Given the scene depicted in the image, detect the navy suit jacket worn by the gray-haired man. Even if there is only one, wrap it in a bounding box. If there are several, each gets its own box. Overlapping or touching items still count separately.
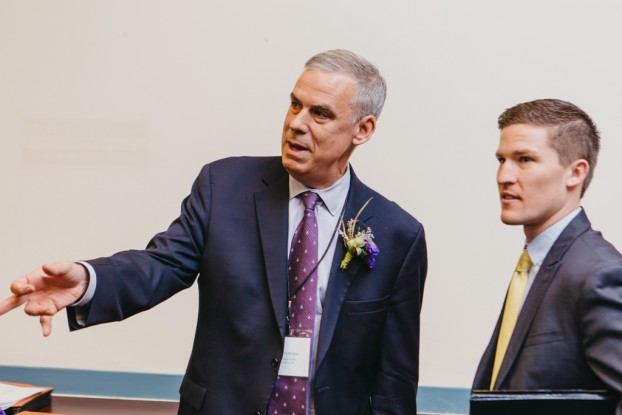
[69,157,427,415]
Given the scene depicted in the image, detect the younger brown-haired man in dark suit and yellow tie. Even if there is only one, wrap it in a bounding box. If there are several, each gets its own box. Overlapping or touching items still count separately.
[473,99,622,413]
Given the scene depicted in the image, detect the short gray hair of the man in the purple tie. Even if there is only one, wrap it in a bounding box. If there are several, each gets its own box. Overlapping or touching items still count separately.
[305,49,387,122]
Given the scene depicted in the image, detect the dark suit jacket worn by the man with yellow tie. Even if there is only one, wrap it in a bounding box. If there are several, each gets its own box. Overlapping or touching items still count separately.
[473,211,622,413]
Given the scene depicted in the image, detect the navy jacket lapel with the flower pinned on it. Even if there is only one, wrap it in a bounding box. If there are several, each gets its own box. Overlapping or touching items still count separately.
[315,170,374,368]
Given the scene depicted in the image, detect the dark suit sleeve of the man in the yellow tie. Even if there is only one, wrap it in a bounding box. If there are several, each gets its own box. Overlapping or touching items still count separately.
[579,264,622,415]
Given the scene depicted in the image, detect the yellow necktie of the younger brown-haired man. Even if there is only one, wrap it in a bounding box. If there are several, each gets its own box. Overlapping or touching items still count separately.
[490,248,532,390]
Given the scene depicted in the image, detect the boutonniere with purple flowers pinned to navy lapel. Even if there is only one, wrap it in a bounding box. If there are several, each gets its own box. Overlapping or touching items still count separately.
[339,197,380,269]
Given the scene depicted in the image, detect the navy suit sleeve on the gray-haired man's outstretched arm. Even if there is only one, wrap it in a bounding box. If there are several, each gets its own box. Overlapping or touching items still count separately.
[68,165,211,329]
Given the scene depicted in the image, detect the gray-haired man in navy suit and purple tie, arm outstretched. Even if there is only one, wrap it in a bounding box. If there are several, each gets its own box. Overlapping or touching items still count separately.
[0,50,427,415]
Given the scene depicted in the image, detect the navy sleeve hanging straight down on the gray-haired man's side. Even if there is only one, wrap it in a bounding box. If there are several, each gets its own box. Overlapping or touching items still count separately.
[371,225,427,415]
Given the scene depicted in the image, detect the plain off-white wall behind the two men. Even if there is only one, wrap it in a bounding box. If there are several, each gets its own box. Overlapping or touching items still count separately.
[0,0,622,387]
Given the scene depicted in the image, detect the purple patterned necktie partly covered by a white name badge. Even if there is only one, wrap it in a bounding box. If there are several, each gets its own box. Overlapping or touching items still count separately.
[267,192,320,415]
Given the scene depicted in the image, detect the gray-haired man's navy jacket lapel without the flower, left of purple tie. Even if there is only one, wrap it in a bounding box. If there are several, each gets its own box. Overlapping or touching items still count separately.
[255,159,289,337]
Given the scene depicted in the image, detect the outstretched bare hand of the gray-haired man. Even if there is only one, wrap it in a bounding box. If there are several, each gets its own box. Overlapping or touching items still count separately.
[0,261,89,336]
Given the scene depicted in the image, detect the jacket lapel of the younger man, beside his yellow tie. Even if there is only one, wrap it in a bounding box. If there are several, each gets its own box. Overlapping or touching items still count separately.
[492,211,590,387]
